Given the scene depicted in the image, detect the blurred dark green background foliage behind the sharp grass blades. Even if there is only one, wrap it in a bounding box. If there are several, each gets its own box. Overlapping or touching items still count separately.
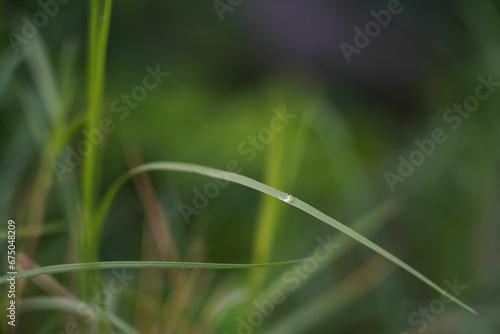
[0,0,500,334]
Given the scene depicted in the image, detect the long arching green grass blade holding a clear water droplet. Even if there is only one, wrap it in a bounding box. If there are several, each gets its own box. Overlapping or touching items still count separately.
[96,162,478,315]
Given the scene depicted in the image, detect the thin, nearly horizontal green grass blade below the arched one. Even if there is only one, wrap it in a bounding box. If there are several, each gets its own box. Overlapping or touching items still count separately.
[0,258,307,285]
